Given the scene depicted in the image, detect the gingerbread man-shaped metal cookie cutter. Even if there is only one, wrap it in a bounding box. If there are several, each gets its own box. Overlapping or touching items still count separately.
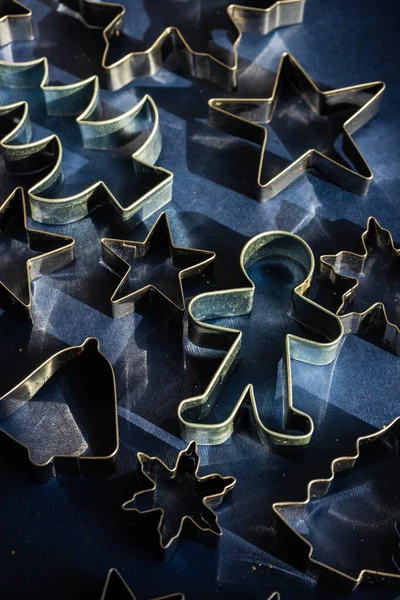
[178,231,343,452]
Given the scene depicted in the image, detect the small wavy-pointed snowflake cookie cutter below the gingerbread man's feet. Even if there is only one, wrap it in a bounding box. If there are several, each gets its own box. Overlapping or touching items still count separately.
[122,442,236,551]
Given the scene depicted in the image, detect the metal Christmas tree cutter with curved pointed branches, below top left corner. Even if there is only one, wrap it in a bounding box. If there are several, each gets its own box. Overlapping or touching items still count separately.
[0,58,173,227]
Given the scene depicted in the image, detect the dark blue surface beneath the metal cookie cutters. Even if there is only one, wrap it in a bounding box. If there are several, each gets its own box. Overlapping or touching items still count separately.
[0,0,400,600]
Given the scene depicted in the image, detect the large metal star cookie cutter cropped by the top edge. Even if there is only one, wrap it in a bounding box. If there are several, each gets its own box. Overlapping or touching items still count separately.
[57,0,306,90]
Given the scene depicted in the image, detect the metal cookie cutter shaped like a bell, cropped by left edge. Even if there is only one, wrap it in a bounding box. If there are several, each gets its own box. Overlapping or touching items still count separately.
[0,338,119,481]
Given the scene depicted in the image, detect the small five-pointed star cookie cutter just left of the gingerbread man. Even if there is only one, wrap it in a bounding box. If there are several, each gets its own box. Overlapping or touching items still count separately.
[101,212,216,318]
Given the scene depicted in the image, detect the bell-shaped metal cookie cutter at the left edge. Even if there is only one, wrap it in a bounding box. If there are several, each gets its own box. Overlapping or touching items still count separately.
[0,338,119,481]
